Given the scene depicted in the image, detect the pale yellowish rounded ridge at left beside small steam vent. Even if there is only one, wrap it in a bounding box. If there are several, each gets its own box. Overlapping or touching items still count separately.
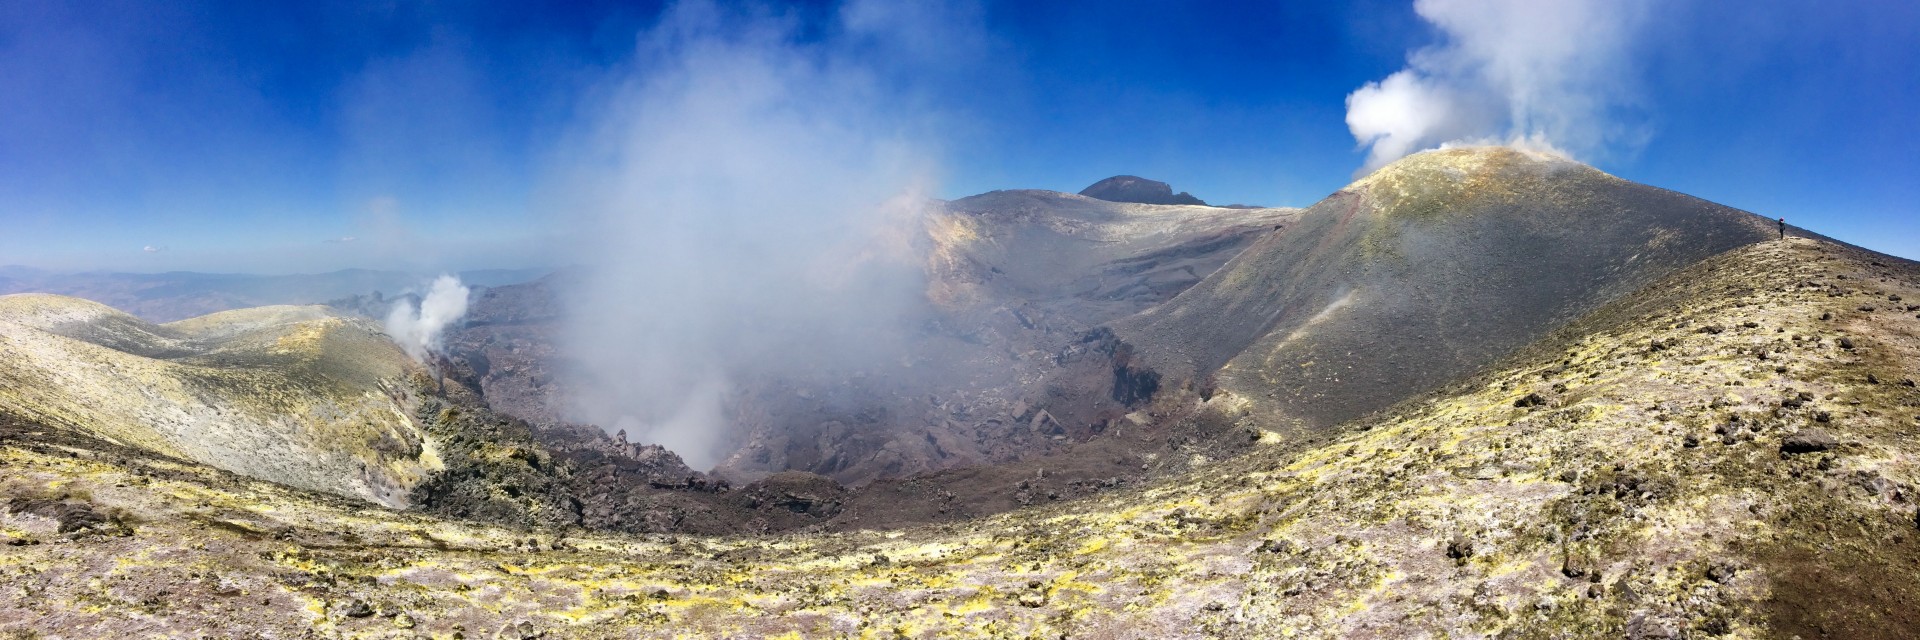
[0,294,444,507]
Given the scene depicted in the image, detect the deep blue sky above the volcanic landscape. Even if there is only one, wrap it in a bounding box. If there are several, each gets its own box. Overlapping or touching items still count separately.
[0,0,1920,273]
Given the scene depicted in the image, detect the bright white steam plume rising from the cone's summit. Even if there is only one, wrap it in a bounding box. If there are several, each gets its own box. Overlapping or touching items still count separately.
[1346,0,1649,173]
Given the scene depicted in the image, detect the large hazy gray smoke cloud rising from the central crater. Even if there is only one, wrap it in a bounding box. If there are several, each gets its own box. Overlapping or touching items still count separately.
[553,4,941,469]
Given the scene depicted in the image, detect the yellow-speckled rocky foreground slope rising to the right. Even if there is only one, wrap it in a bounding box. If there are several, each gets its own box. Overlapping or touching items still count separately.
[0,238,1920,638]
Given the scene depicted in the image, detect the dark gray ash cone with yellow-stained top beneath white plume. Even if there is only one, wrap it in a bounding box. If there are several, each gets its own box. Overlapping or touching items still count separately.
[1112,148,1812,432]
